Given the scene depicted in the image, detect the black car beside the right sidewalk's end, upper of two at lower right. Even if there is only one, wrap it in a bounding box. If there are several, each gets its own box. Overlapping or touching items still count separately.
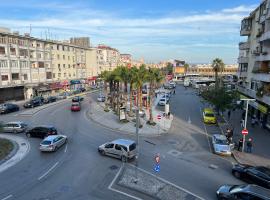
[232,165,270,188]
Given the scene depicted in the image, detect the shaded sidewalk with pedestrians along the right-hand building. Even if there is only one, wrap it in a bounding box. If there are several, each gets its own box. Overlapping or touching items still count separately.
[219,110,270,165]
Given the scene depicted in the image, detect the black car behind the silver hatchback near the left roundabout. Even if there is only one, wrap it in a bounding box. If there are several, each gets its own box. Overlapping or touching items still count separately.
[26,126,57,138]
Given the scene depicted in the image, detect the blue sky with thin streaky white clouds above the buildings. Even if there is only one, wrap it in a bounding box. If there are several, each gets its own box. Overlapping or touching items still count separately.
[0,0,261,64]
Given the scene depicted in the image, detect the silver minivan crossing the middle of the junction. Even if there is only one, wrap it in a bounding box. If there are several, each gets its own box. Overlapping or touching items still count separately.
[98,139,136,162]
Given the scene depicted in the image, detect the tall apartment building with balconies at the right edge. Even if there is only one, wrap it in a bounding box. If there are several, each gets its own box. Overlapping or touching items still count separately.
[238,0,270,128]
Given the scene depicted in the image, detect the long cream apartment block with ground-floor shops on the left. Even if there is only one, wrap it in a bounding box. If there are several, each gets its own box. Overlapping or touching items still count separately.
[0,28,97,102]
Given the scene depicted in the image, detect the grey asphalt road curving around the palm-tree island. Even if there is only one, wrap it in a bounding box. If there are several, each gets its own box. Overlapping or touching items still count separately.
[0,86,241,200]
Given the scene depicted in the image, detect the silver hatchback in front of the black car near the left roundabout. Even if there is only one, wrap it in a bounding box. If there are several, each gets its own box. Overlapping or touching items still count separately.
[39,135,67,151]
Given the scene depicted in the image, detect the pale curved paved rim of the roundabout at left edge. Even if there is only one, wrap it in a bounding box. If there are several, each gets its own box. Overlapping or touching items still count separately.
[0,134,30,173]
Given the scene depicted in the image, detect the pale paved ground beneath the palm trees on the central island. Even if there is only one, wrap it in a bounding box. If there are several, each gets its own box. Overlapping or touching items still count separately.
[87,95,173,136]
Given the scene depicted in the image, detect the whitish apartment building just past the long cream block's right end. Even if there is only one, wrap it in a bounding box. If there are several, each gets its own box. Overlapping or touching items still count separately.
[97,44,120,73]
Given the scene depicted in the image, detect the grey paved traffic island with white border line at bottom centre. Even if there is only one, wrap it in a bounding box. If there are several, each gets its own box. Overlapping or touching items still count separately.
[111,165,201,200]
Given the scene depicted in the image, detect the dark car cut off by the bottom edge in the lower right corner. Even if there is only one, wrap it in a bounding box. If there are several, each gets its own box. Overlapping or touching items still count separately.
[216,185,270,200]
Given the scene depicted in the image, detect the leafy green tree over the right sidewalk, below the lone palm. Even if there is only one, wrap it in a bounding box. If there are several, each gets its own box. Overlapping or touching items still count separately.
[201,87,238,113]
